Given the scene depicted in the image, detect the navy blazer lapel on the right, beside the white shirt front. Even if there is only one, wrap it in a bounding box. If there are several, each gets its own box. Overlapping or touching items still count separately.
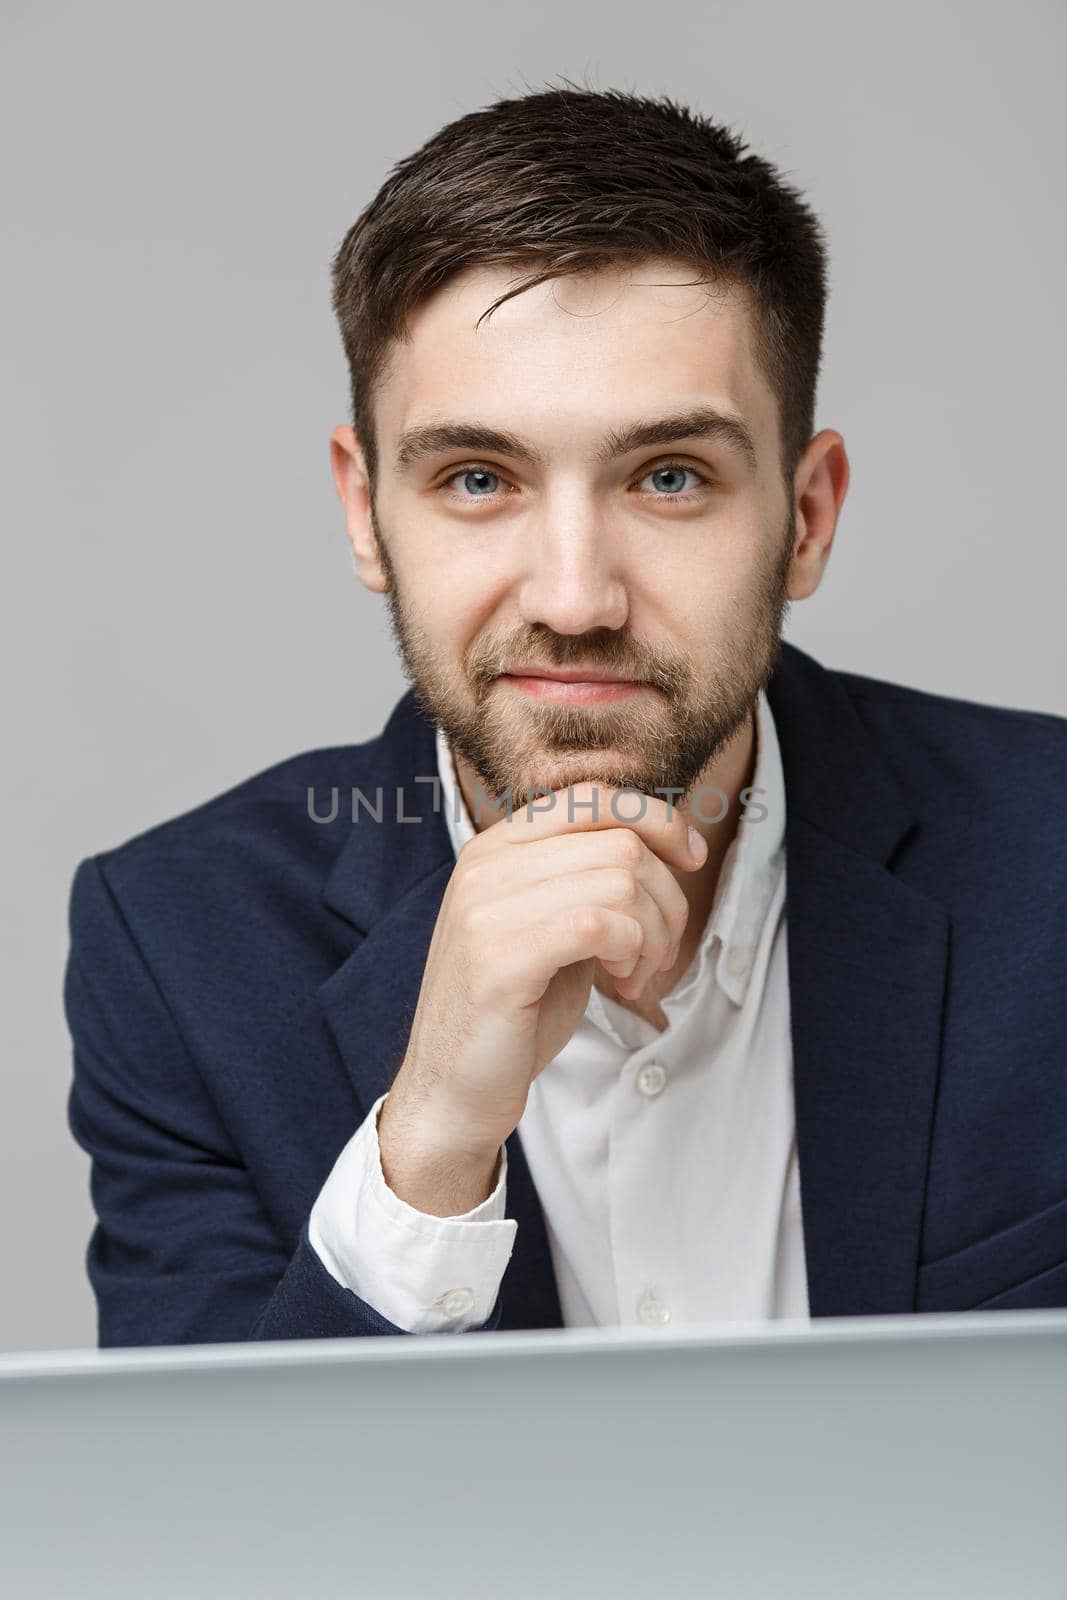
[768,645,950,1317]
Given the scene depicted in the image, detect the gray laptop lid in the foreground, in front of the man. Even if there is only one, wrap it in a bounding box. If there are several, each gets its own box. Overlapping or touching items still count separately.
[0,1312,1067,1600]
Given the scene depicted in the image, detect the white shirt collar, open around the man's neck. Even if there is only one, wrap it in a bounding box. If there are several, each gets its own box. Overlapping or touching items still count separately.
[437,690,785,1005]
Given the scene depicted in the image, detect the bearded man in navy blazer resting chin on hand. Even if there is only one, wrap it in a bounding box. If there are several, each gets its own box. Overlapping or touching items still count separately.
[66,90,1067,1346]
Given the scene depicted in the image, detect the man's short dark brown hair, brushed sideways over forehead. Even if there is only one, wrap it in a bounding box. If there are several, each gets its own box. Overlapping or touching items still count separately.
[333,80,827,491]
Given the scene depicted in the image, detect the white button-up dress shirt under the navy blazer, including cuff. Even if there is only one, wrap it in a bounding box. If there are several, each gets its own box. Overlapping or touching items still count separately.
[309,693,808,1333]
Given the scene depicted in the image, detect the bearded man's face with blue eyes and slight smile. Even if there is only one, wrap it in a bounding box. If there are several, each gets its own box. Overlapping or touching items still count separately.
[358,262,793,805]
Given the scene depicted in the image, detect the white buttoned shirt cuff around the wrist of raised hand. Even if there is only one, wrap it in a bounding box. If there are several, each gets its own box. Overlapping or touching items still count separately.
[307,1094,518,1333]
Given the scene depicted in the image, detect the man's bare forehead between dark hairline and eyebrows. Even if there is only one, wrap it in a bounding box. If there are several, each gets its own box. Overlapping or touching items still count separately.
[376,259,777,451]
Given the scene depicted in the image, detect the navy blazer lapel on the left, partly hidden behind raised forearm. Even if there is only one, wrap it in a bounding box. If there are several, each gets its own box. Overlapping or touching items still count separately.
[318,690,563,1328]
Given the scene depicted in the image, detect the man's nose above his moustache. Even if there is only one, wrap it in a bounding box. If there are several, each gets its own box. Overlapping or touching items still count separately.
[518,514,629,634]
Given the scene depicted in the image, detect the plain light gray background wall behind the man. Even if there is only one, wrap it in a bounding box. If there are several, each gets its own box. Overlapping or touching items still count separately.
[0,0,1067,1350]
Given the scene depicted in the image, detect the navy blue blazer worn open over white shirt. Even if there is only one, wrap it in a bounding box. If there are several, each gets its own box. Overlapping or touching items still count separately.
[64,645,1067,1346]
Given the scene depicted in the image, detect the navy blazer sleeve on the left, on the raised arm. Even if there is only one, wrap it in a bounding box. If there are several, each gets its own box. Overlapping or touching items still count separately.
[64,856,501,1347]
